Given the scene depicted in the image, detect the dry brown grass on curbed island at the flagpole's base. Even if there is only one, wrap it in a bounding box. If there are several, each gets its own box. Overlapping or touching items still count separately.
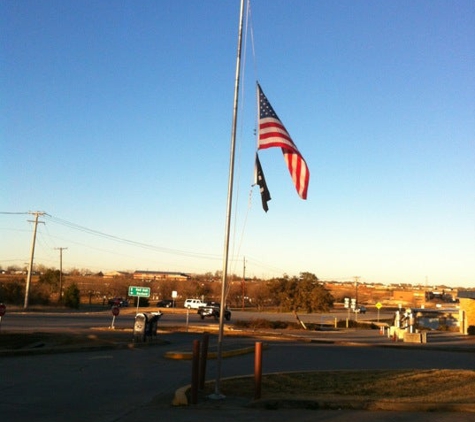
[206,369,475,403]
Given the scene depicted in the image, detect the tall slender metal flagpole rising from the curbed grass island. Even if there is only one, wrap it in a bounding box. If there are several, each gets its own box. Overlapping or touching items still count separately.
[214,0,244,399]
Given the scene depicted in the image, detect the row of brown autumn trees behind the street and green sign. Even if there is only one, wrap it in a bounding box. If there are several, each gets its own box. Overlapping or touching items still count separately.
[0,268,335,313]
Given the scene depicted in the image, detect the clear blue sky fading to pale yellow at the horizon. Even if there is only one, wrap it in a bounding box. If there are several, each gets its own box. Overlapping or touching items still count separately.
[0,0,475,287]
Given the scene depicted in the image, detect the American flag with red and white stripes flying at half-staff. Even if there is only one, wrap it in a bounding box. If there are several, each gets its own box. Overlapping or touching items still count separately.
[257,84,310,199]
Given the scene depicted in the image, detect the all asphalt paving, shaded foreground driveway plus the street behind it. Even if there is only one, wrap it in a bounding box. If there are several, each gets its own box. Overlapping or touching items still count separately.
[0,309,475,422]
